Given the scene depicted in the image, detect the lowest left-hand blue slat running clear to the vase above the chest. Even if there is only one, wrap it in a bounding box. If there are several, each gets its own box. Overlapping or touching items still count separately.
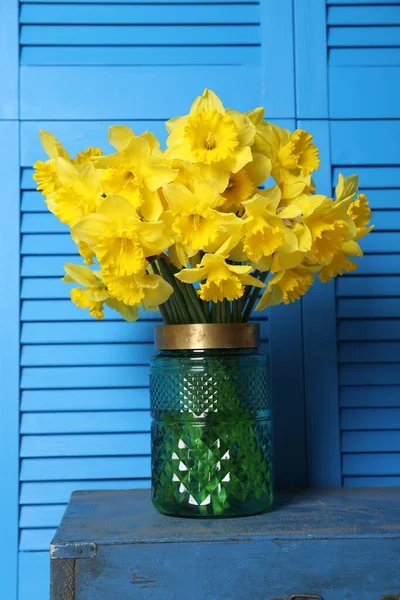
[20,456,150,481]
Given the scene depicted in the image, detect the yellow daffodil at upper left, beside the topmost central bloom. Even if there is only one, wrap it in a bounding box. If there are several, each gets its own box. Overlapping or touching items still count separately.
[94,136,176,221]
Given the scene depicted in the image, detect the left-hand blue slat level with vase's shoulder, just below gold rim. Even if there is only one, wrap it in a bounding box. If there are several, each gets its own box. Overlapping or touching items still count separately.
[21,343,155,367]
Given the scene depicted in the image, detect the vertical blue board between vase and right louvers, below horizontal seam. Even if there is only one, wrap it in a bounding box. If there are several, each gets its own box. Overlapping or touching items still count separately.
[299,120,342,486]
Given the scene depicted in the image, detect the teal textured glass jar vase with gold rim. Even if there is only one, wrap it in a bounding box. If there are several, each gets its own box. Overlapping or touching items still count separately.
[150,324,273,517]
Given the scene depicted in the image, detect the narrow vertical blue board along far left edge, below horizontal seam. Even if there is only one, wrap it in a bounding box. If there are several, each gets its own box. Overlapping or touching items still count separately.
[0,120,20,600]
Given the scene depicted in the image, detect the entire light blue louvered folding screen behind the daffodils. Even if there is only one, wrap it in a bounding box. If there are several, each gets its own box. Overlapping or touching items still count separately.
[0,0,400,600]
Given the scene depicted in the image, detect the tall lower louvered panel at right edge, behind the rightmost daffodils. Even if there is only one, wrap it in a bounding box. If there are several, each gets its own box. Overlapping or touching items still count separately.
[330,116,400,486]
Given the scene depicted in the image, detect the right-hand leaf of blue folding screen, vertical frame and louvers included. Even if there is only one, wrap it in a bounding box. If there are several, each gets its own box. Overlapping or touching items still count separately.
[294,0,400,486]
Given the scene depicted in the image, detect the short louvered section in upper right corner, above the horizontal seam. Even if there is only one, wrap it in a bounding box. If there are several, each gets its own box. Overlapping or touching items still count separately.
[327,2,400,117]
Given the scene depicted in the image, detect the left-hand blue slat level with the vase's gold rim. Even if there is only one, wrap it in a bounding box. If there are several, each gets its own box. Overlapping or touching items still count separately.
[21,321,153,344]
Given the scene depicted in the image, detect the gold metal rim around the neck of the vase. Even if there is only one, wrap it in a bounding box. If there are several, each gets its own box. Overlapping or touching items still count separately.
[154,323,260,350]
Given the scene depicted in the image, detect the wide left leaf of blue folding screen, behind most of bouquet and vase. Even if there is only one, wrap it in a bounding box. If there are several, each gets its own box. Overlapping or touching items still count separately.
[0,0,306,600]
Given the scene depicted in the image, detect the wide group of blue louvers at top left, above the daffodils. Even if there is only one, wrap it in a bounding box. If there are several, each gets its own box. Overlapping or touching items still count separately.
[20,1,261,66]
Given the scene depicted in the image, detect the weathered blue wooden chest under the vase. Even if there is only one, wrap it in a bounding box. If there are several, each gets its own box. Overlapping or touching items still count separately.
[50,488,400,600]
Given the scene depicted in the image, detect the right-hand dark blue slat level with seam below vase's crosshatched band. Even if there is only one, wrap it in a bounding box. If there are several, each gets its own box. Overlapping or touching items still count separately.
[340,408,400,432]
